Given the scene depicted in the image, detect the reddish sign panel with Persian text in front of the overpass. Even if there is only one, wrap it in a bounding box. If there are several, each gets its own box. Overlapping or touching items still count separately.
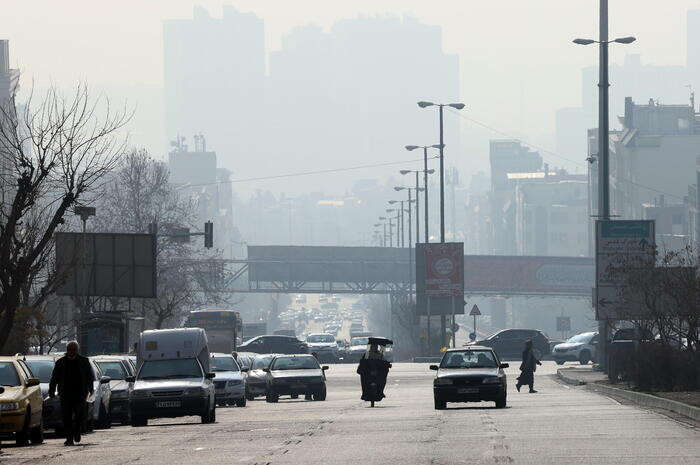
[424,242,464,297]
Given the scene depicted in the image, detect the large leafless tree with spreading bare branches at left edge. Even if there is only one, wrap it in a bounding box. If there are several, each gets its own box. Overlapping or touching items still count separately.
[0,85,131,347]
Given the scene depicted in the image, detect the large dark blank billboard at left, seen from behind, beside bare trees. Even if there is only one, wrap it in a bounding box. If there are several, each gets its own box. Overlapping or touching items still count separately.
[55,233,157,298]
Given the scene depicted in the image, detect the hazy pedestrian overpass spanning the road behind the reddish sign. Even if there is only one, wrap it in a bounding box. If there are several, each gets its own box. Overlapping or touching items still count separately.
[211,246,595,298]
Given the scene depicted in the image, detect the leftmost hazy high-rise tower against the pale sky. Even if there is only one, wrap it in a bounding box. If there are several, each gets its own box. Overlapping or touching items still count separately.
[163,6,265,167]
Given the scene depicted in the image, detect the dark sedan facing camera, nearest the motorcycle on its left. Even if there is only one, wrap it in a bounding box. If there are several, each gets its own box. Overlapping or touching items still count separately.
[263,354,328,402]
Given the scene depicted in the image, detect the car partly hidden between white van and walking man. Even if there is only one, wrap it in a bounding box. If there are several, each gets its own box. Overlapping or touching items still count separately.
[92,355,136,425]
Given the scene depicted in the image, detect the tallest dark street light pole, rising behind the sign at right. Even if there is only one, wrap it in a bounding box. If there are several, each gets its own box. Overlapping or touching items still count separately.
[574,0,637,372]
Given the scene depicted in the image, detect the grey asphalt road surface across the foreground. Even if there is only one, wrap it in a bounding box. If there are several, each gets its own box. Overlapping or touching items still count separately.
[0,362,700,465]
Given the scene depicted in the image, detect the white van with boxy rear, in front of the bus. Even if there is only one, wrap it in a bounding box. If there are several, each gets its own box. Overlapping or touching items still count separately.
[127,328,216,426]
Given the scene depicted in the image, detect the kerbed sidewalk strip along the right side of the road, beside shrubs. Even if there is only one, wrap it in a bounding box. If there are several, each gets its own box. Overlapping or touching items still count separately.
[557,366,700,421]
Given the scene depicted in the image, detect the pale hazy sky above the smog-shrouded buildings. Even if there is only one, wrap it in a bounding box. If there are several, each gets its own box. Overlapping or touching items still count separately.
[0,0,700,191]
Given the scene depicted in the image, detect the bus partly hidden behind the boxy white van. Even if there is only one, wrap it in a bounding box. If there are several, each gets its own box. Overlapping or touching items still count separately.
[185,308,242,354]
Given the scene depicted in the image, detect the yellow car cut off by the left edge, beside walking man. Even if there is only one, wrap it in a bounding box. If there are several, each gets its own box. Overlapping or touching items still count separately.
[0,357,44,446]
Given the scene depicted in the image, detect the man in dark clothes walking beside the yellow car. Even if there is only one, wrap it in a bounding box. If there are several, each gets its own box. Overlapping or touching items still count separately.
[49,341,95,446]
